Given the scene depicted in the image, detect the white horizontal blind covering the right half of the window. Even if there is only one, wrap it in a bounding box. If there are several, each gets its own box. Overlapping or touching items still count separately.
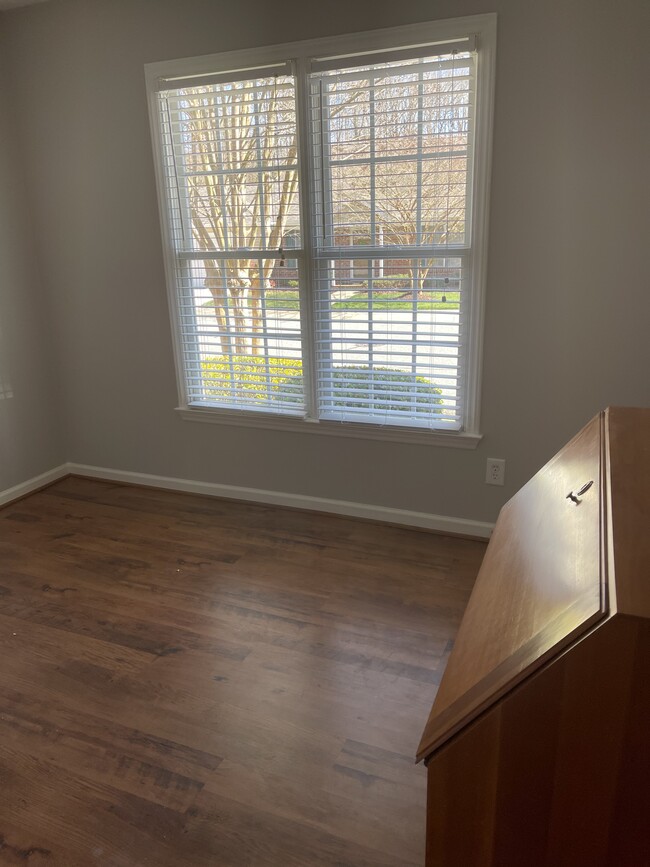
[310,51,475,430]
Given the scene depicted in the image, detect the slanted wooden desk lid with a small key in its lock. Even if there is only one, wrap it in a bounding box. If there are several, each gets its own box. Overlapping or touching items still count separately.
[418,416,606,758]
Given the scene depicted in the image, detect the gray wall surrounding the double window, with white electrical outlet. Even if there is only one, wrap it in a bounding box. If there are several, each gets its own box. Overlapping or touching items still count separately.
[0,0,650,520]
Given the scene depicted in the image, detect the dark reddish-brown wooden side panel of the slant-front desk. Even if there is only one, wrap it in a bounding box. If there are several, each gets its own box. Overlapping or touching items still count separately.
[426,615,650,867]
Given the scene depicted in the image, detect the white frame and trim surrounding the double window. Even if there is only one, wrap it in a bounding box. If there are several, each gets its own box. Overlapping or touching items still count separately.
[145,13,496,449]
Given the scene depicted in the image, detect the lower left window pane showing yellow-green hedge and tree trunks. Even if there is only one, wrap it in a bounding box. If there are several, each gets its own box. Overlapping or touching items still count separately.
[178,258,304,415]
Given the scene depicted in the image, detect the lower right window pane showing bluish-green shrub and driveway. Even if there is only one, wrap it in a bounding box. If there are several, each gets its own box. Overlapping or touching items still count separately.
[316,258,463,428]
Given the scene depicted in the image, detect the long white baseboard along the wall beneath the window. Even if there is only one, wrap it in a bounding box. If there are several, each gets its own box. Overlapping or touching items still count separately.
[67,463,494,539]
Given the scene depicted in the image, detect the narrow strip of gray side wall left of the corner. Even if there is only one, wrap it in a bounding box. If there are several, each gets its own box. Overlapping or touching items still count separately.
[0,64,65,491]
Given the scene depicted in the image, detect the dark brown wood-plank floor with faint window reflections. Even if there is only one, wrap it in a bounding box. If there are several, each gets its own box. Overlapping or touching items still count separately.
[0,478,485,867]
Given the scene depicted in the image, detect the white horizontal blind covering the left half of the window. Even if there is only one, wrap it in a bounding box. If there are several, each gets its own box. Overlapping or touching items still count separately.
[158,68,304,415]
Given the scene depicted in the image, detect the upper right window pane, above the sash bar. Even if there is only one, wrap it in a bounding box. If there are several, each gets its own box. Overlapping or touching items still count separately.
[312,55,473,246]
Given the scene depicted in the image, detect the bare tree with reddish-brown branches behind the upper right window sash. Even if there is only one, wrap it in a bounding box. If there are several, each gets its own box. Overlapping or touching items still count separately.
[331,73,468,292]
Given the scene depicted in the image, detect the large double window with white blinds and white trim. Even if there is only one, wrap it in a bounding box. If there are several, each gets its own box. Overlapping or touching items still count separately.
[147,16,494,439]
